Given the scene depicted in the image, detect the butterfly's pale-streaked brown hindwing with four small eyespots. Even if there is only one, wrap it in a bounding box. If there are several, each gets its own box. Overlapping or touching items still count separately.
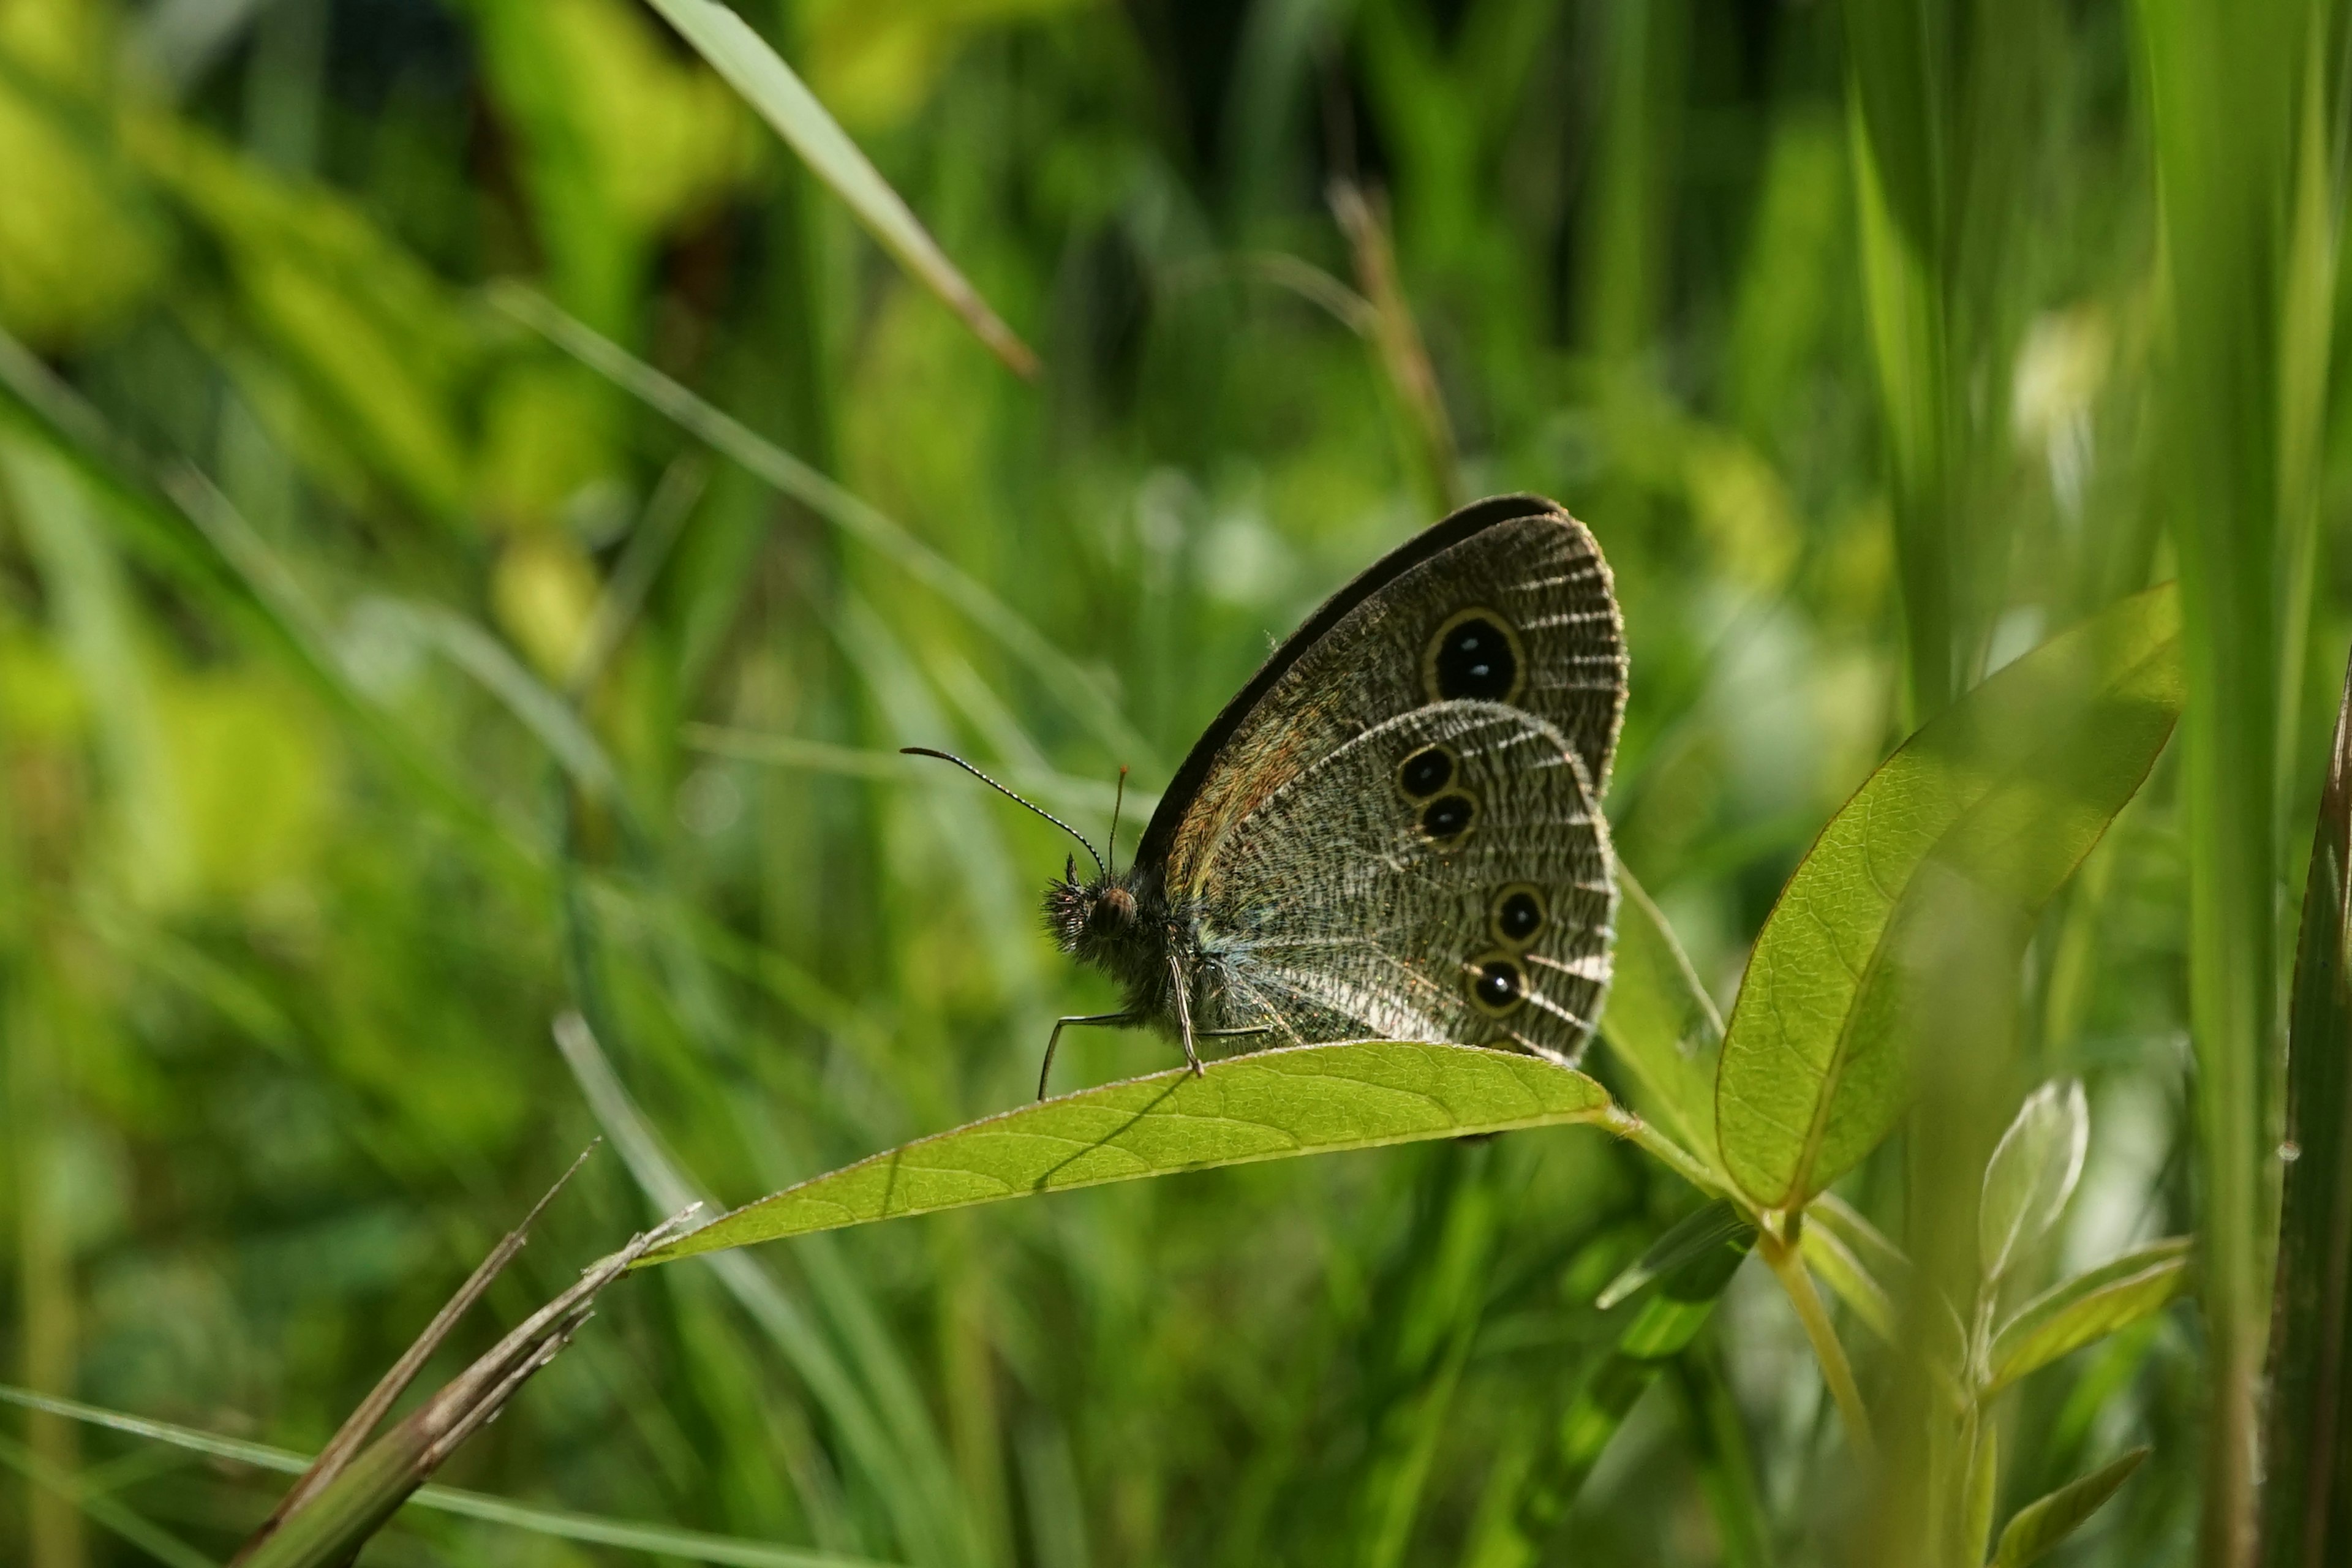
[1195,701,1616,1060]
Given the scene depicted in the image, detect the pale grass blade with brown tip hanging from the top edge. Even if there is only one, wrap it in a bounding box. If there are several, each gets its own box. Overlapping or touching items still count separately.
[647,0,1037,379]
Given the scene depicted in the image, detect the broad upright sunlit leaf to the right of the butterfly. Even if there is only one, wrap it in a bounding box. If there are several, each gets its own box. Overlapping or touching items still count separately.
[1714,586,2180,1208]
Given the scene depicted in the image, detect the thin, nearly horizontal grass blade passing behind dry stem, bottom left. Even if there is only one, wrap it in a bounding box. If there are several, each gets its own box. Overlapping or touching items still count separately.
[0,1385,891,1568]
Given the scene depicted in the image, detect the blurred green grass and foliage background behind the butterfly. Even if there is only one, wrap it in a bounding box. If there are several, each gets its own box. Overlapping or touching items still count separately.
[0,0,2352,1568]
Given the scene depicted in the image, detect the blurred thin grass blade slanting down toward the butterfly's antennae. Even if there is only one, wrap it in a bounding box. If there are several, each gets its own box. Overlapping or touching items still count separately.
[487,282,1153,766]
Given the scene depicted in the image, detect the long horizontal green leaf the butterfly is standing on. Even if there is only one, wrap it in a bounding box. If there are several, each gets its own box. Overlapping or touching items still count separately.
[644,1041,1635,1265]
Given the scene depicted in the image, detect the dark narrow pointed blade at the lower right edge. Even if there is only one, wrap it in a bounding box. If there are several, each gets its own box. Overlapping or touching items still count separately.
[2263,644,2352,1568]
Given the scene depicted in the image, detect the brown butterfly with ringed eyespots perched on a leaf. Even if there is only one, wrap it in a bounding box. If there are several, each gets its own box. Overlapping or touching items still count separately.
[908,496,1625,1098]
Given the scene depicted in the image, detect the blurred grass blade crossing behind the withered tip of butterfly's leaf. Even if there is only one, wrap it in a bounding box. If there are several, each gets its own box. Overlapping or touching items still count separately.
[555,1013,971,1563]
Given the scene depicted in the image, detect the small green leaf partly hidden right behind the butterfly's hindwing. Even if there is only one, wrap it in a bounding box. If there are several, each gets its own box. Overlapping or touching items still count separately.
[1602,863,1724,1159]
